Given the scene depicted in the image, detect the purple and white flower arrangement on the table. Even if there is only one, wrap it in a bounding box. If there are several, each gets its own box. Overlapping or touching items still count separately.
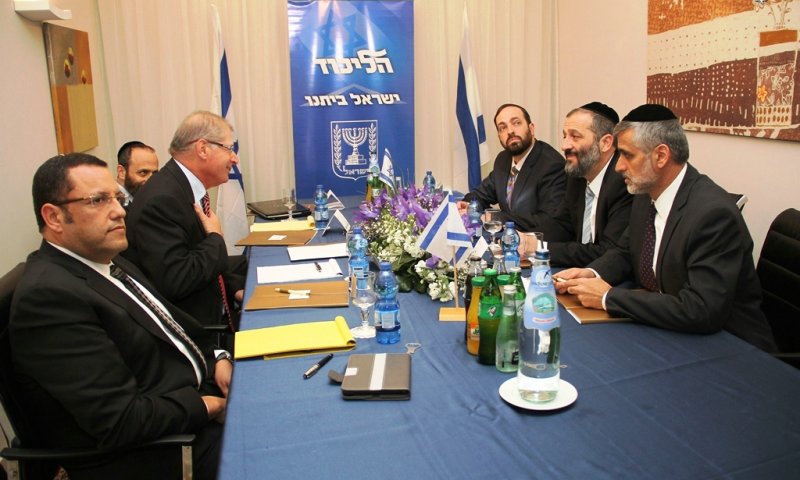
[353,184,455,302]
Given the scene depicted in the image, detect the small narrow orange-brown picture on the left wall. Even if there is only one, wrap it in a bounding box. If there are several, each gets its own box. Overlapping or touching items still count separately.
[42,23,97,153]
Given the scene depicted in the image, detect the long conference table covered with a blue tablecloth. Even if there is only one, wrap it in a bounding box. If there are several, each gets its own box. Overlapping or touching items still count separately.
[219,201,800,480]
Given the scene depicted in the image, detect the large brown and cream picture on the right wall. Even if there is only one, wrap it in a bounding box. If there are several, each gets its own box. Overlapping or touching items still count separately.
[647,0,800,141]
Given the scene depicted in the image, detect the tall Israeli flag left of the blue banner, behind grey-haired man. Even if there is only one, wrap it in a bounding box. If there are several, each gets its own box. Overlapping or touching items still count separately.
[211,5,250,255]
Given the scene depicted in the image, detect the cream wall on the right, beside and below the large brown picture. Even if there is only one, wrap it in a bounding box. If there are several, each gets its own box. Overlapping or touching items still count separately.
[558,0,800,259]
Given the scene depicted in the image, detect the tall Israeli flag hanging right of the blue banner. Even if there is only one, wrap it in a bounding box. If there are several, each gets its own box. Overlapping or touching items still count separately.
[454,5,489,190]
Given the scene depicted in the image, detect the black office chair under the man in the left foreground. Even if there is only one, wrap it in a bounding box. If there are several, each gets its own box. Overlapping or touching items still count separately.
[0,263,195,480]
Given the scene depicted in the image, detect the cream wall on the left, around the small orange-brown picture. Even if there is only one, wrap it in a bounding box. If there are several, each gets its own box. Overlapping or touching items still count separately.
[0,0,116,274]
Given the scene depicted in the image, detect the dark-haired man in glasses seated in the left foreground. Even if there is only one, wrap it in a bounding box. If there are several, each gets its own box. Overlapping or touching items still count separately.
[9,153,232,478]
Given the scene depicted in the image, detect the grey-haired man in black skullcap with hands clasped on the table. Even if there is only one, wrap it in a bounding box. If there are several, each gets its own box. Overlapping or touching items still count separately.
[556,104,774,351]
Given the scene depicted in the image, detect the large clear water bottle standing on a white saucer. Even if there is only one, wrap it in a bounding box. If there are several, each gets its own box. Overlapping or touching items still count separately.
[517,243,561,402]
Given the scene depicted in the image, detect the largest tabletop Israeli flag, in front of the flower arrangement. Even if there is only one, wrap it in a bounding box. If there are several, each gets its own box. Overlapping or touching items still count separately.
[417,192,472,264]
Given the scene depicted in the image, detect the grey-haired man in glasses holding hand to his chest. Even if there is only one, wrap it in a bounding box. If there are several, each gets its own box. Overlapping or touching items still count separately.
[123,111,247,330]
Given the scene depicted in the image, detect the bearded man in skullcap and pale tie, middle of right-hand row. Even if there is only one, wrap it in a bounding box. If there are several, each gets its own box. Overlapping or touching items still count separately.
[520,102,633,267]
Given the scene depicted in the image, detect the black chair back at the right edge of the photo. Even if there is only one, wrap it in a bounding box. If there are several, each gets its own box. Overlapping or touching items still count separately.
[756,208,800,368]
